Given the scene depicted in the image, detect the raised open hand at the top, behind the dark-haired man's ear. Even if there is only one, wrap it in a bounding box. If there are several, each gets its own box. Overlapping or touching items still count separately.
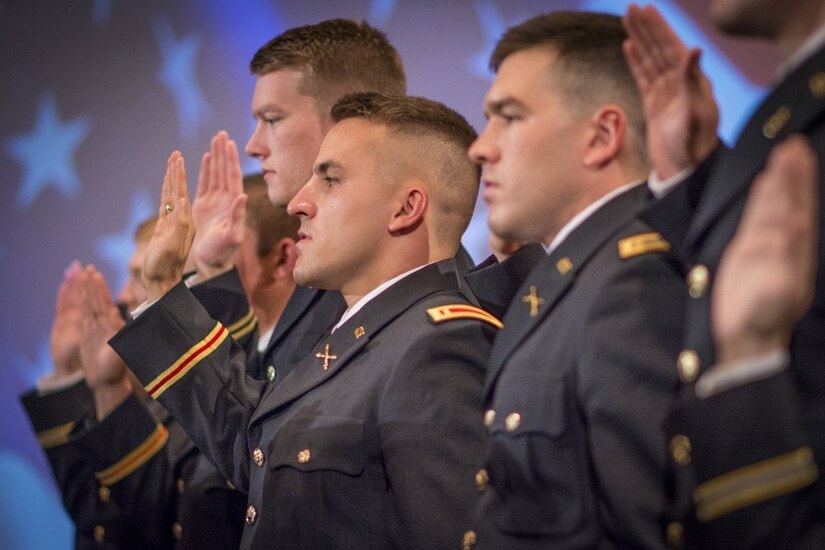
[622,6,719,179]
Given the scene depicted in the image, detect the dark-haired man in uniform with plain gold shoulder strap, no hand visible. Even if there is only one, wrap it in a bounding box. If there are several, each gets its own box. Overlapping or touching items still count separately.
[463,12,682,549]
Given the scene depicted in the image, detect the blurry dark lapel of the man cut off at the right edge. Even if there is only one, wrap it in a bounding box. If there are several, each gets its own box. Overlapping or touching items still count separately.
[685,48,825,249]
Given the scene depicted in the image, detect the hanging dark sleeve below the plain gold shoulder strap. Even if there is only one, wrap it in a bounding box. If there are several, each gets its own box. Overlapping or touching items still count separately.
[577,254,683,548]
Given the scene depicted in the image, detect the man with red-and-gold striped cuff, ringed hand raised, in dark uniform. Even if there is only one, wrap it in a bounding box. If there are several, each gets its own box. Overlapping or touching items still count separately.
[104,94,500,548]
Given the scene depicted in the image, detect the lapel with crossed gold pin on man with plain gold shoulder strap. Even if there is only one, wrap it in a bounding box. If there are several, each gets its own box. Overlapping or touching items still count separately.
[484,185,649,401]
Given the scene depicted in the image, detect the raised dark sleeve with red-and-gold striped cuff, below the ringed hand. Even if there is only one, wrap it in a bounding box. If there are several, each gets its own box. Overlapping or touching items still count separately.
[109,283,266,490]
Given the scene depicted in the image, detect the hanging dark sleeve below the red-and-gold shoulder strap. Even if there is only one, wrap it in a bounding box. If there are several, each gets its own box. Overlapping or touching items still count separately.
[379,320,493,549]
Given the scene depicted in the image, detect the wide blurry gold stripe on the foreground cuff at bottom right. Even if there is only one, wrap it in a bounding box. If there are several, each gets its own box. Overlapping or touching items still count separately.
[693,447,819,522]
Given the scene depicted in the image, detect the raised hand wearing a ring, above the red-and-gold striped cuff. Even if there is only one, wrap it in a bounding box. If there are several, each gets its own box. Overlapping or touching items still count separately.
[143,151,195,302]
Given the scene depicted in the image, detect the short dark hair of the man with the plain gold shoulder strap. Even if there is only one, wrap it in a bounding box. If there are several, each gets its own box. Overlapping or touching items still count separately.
[490,11,647,164]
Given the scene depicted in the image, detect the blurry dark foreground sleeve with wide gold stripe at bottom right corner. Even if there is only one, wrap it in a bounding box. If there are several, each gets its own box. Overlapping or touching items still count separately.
[669,369,825,548]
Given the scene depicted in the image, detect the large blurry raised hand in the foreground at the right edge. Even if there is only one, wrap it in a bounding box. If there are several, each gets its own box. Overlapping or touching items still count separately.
[711,136,819,365]
